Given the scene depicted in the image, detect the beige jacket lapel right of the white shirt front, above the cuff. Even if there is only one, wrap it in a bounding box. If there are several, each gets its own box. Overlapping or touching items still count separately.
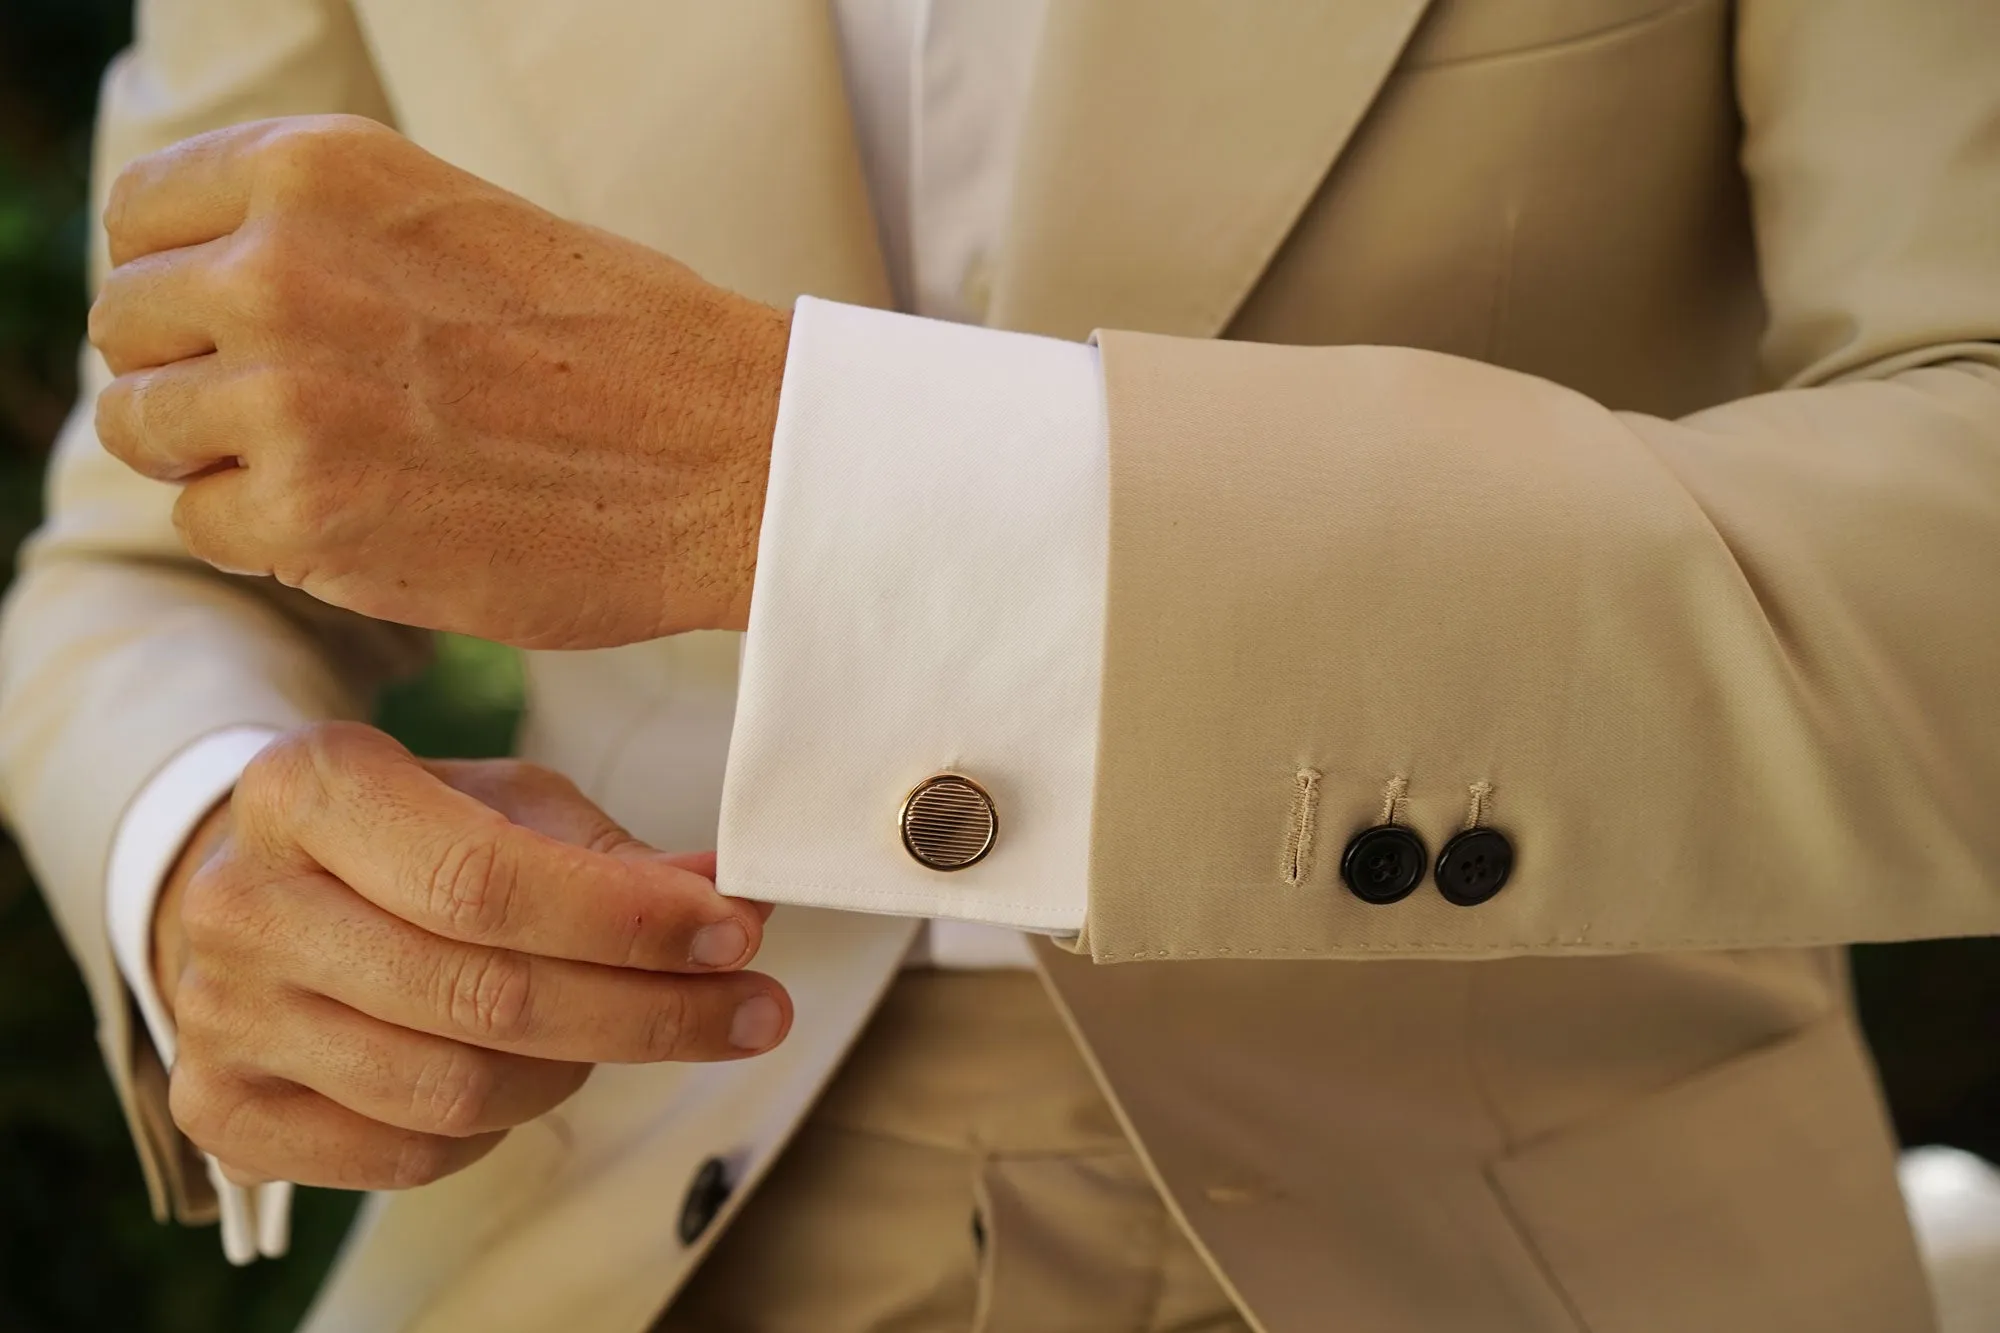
[988,0,1430,338]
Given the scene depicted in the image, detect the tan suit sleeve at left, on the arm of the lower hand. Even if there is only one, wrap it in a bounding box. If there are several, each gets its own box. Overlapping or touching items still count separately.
[0,0,422,1219]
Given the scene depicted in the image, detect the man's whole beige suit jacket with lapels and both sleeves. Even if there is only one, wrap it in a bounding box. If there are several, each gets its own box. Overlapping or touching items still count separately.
[0,0,2000,1333]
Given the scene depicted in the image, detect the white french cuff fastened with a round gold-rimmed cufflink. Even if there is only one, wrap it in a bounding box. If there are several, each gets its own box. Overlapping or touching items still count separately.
[718,298,1110,935]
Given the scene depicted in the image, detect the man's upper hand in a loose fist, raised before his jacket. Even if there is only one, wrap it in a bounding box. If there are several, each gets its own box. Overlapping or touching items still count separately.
[90,116,790,648]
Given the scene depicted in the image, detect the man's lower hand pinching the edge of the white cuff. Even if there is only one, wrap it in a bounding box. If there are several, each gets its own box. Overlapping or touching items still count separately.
[154,725,792,1189]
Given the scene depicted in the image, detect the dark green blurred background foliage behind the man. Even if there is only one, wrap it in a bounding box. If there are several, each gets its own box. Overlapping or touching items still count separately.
[0,0,2000,1333]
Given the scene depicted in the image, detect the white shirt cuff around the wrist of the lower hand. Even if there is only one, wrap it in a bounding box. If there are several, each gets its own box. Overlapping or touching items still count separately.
[104,727,292,1265]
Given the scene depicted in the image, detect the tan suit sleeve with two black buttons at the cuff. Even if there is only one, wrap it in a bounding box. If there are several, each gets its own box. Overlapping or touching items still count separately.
[1084,0,2000,961]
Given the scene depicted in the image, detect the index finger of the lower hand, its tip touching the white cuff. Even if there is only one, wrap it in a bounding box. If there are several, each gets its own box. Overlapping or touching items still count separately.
[262,727,762,973]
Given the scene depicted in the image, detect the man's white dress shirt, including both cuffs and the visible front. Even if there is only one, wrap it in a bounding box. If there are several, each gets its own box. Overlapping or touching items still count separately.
[106,0,1108,1263]
